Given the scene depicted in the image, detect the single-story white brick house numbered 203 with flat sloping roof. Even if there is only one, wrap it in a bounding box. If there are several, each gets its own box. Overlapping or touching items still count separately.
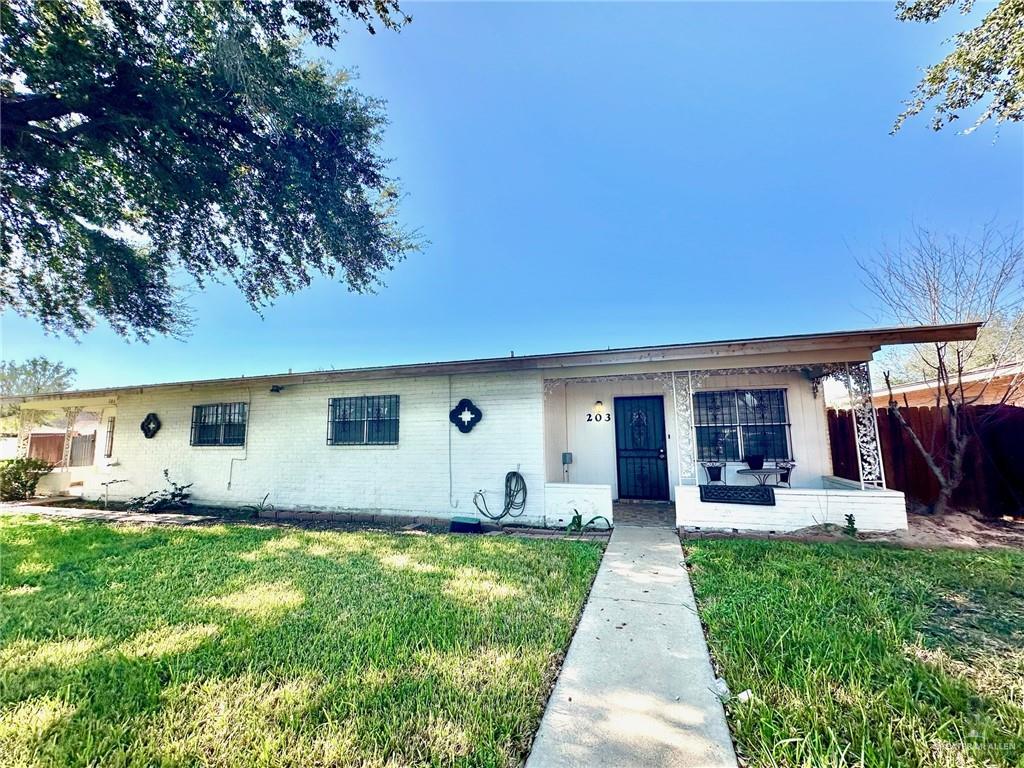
[2,324,978,530]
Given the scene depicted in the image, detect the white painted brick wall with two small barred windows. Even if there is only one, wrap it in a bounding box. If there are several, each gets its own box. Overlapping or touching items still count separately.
[88,373,544,521]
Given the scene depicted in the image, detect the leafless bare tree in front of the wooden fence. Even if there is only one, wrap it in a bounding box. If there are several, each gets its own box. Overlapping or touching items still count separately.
[859,225,1024,515]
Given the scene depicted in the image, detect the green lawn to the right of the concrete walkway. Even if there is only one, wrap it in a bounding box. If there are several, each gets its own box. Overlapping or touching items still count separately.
[685,540,1024,768]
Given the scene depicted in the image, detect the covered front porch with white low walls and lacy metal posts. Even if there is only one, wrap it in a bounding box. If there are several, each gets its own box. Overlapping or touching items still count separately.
[545,356,906,532]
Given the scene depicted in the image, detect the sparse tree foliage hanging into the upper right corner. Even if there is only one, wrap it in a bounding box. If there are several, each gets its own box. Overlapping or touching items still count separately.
[894,0,1024,130]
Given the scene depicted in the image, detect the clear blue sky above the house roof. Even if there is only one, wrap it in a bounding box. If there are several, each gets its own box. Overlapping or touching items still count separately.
[3,2,1024,387]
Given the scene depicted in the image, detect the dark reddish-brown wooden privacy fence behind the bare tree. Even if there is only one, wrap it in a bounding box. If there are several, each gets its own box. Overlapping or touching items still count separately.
[828,406,1024,517]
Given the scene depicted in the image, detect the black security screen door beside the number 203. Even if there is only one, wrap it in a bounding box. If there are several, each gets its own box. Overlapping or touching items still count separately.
[615,397,669,501]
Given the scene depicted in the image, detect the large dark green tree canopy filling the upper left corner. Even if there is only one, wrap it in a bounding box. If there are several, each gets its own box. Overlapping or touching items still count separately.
[0,0,416,339]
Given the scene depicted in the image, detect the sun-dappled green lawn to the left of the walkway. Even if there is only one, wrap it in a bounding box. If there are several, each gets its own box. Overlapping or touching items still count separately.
[0,517,601,768]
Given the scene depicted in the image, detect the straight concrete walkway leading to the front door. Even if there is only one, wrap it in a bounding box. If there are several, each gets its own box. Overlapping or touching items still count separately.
[526,525,736,768]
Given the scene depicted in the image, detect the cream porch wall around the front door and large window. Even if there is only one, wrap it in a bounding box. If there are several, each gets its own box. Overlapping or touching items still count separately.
[545,373,831,499]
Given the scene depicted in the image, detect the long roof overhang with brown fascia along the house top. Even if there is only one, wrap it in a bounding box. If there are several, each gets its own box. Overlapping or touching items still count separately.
[0,323,982,409]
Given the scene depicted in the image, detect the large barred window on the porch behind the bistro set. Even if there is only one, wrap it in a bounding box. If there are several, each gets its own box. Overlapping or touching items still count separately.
[693,389,792,462]
